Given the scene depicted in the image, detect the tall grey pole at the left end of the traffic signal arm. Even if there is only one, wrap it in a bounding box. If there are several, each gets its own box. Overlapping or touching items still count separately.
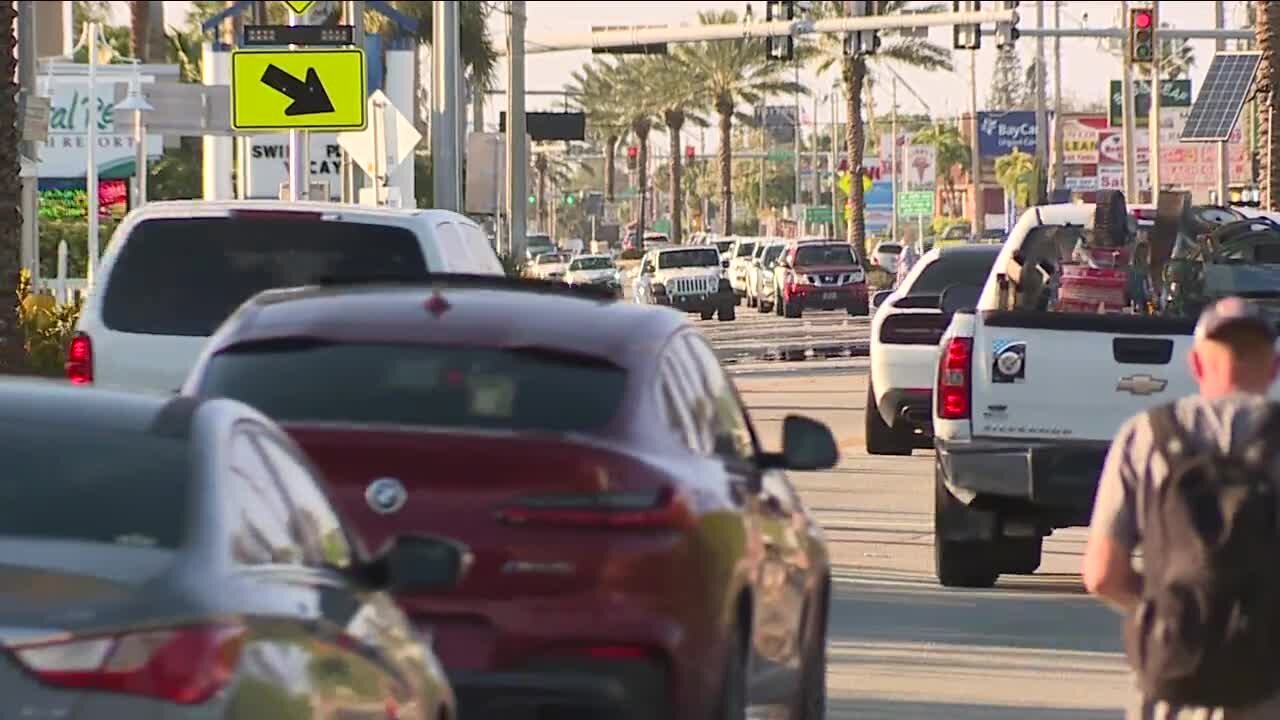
[507,0,529,263]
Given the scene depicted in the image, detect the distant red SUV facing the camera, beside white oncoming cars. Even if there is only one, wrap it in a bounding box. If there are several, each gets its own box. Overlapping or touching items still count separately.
[773,240,870,318]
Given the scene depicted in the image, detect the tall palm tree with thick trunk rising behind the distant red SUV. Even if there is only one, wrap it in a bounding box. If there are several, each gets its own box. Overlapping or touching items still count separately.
[814,0,952,258]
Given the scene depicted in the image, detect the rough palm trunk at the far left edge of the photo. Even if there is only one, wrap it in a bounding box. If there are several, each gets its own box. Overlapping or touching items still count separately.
[0,0,28,373]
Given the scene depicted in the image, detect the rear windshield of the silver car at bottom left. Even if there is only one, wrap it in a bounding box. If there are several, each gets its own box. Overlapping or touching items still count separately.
[0,423,192,548]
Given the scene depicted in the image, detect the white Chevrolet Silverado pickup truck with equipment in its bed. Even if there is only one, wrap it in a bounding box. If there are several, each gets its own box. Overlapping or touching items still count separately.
[933,198,1280,587]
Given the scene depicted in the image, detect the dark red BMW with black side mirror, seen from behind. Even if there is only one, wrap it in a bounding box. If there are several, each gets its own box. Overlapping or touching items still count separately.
[183,277,837,720]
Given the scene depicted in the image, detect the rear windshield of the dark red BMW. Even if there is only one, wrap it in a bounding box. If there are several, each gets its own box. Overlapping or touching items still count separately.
[200,341,626,433]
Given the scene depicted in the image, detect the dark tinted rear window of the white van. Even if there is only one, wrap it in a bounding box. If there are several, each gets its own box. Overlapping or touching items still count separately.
[102,217,428,337]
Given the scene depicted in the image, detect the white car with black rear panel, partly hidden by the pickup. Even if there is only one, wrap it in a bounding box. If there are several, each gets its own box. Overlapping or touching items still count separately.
[864,245,1001,455]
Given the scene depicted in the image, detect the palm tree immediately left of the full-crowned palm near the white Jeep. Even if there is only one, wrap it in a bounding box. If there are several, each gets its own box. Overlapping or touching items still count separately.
[639,55,708,242]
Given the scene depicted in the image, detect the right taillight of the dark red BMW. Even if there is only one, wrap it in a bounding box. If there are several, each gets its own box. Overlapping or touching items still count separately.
[498,487,692,530]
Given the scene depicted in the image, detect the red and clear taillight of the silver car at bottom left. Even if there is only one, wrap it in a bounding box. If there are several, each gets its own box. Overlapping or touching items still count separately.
[9,625,244,705]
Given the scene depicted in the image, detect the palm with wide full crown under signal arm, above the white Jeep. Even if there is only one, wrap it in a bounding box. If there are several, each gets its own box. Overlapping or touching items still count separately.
[676,10,809,234]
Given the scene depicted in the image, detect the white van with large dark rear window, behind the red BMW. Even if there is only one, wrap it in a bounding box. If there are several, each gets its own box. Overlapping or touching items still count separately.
[67,200,504,392]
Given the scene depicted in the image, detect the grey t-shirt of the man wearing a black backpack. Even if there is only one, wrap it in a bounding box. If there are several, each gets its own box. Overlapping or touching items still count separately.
[1089,393,1280,720]
